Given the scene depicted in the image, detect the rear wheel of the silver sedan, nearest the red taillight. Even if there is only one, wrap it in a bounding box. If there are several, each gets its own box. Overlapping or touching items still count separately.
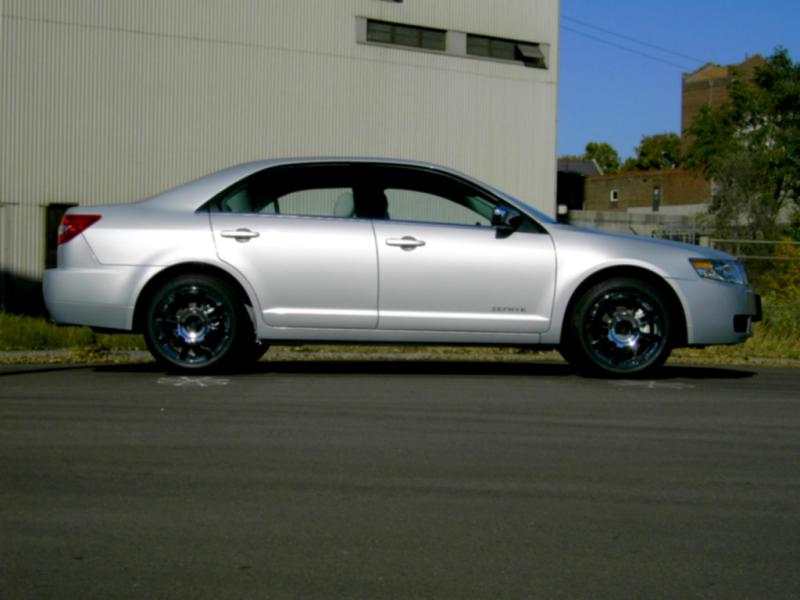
[144,275,253,372]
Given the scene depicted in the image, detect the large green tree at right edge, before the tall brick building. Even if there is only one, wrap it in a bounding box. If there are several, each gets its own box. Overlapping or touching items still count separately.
[686,49,800,239]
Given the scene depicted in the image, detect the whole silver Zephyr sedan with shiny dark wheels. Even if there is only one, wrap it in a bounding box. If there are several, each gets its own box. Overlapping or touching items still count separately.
[44,158,761,375]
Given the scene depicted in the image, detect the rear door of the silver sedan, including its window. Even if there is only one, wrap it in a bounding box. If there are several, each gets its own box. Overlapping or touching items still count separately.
[210,165,378,329]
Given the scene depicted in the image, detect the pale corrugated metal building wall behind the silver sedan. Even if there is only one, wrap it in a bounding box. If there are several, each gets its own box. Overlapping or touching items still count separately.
[0,0,558,304]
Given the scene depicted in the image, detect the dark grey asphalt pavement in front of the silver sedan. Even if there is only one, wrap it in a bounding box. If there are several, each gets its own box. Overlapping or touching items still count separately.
[0,361,800,600]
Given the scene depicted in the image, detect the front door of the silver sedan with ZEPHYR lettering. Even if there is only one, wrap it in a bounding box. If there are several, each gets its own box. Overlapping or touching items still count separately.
[366,167,555,333]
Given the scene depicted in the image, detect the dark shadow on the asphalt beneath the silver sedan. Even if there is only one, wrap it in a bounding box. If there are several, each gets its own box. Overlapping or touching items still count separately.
[87,360,756,380]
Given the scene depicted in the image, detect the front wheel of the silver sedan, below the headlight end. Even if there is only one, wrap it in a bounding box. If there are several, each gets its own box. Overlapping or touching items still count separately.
[561,278,673,376]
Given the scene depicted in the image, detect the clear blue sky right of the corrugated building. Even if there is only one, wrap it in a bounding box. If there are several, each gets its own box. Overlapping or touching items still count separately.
[558,0,800,158]
